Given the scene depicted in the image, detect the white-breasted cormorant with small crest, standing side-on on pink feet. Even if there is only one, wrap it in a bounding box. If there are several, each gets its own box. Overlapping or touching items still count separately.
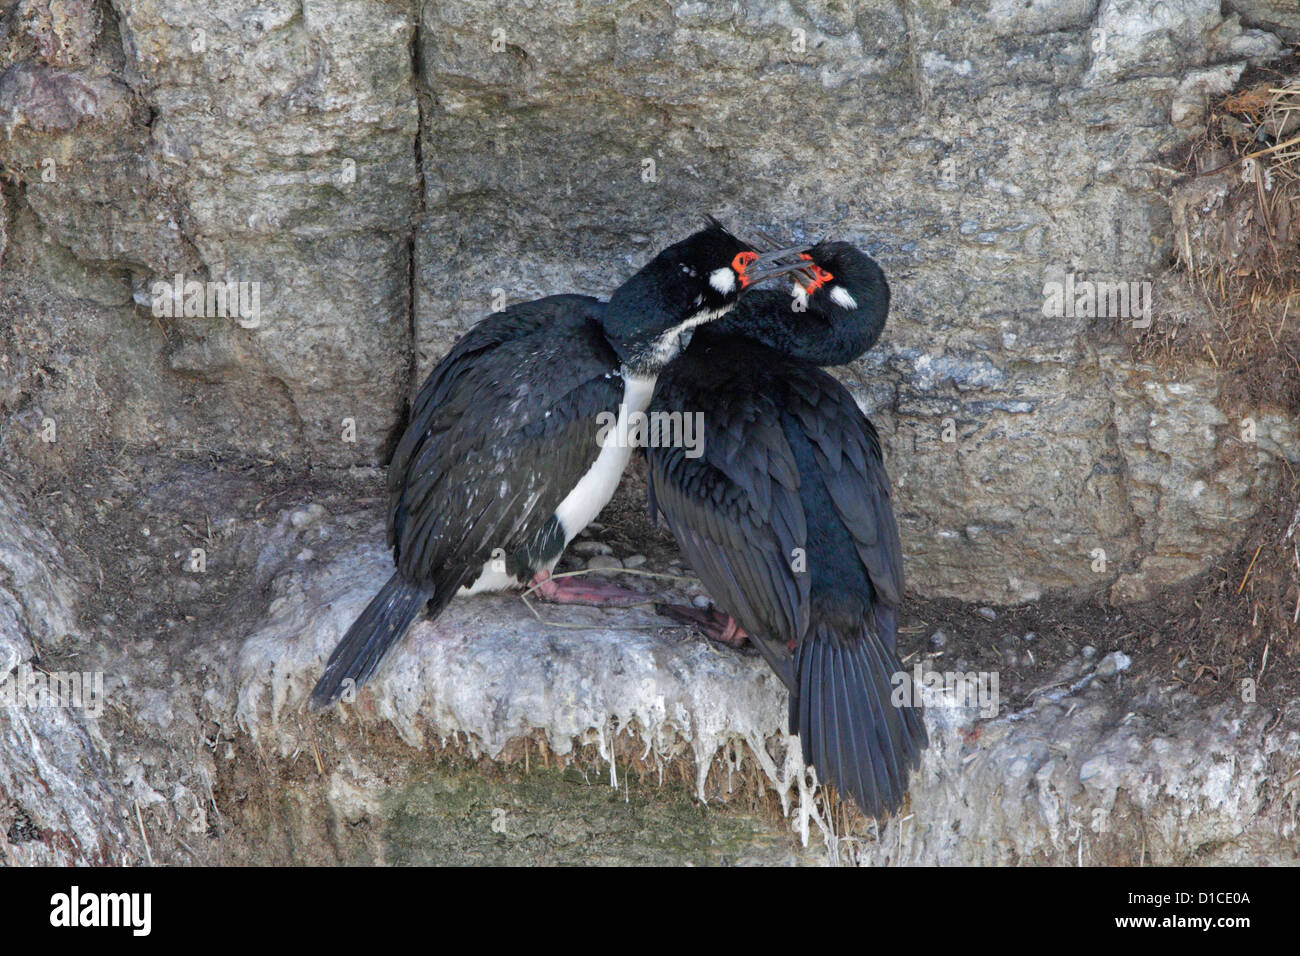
[312,220,806,708]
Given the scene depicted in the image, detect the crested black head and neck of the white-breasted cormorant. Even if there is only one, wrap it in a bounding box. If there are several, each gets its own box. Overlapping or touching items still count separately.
[602,219,797,375]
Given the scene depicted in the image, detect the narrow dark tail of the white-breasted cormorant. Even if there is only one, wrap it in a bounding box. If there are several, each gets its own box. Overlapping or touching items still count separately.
[311,575,439,710]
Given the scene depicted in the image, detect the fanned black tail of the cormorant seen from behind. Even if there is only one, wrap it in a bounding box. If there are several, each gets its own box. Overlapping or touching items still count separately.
[790,622,930,817]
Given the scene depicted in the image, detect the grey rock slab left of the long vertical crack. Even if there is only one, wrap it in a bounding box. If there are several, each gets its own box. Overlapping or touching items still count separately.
[0,0,419,464]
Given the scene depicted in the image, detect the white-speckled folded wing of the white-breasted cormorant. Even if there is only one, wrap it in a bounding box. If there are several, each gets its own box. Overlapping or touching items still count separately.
[389,295,623,580]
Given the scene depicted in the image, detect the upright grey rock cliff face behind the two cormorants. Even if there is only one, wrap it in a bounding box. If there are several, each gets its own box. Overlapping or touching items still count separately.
[0,0,1300,858]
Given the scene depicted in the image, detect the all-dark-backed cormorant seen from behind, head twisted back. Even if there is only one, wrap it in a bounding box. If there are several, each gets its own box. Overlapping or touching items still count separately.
[647,242,928,816]
